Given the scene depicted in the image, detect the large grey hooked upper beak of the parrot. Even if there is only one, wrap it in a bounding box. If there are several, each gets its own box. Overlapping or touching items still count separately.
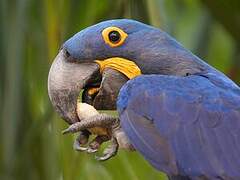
[48,49,99,124]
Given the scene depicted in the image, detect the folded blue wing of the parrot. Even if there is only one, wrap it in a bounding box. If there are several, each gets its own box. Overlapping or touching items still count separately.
[118,75,240,179]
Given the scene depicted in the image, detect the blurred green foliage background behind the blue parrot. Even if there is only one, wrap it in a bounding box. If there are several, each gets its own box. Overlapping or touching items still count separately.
[0,0,240,180]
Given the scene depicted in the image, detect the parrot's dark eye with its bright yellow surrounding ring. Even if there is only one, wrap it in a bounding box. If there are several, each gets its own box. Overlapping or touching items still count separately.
[102,26,128,47]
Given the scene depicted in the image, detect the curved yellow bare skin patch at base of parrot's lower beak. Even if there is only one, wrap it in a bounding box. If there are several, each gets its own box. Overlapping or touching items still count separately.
[95,57,142,79]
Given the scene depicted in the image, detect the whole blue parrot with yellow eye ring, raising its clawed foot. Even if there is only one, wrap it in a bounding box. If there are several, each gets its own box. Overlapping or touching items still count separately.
[48,19,240,180]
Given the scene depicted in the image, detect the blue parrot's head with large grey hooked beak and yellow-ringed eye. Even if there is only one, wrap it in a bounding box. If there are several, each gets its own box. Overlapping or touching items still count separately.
[48,19,205,124]
